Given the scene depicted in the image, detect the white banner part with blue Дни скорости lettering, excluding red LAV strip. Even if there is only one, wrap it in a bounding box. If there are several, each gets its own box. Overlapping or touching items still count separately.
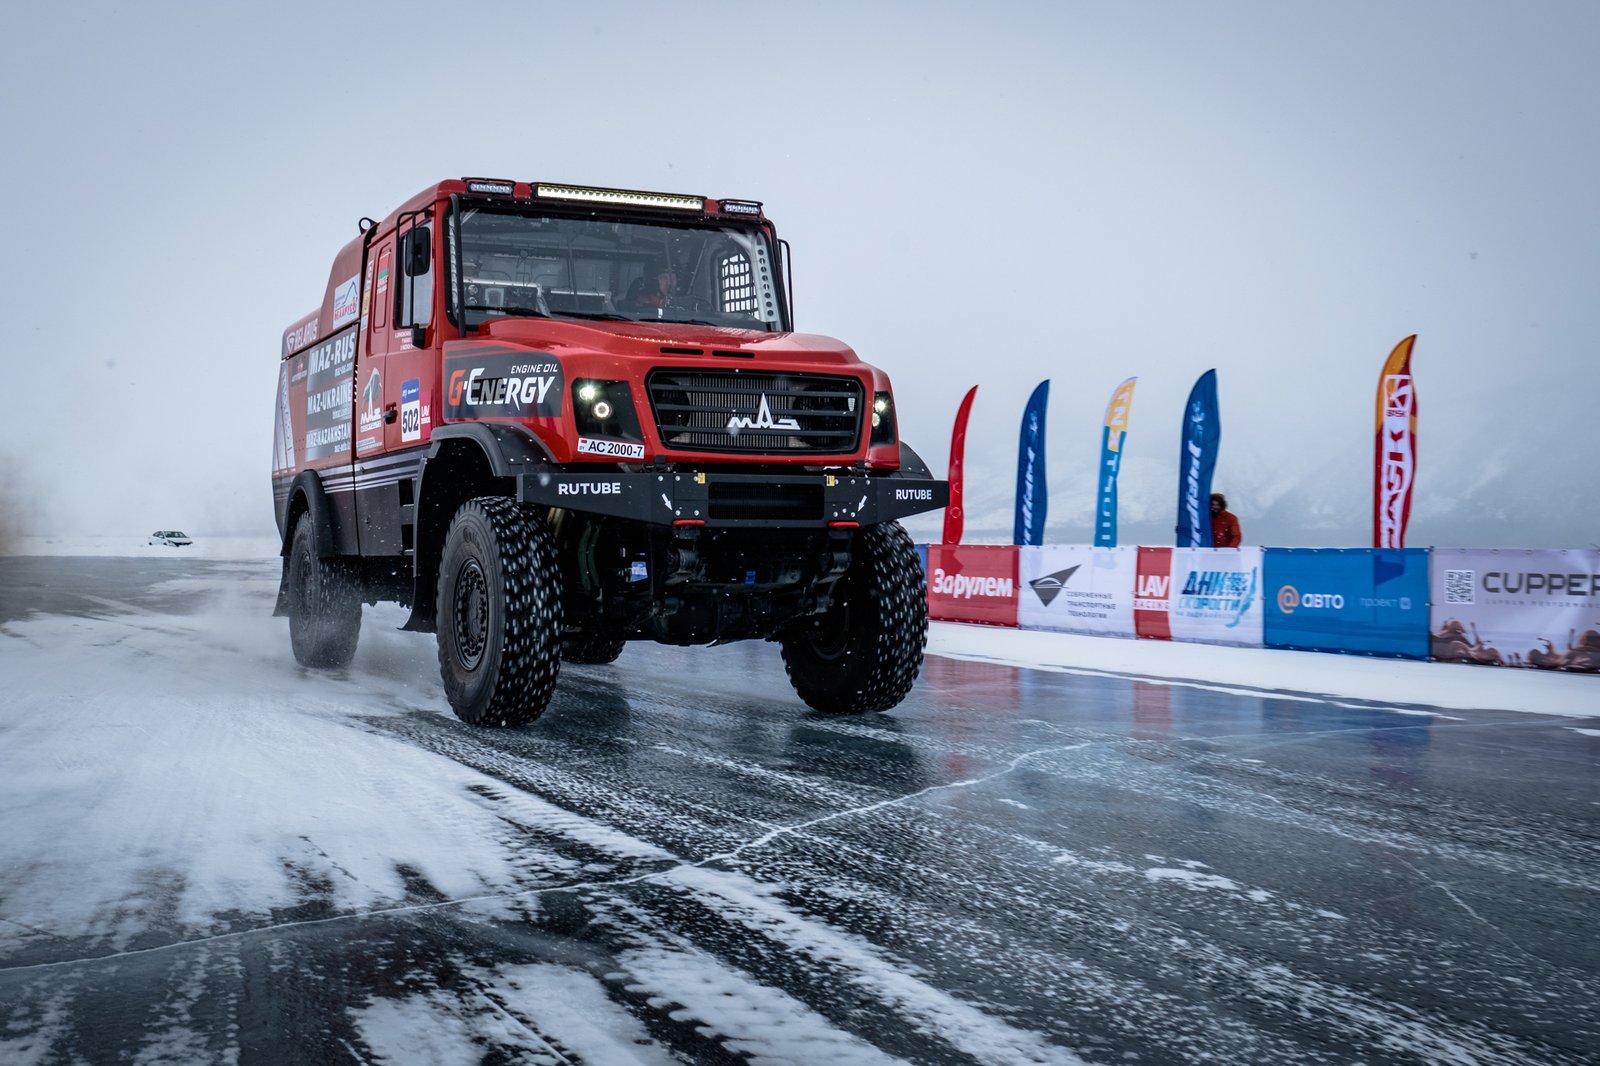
[1166,547,1262,648]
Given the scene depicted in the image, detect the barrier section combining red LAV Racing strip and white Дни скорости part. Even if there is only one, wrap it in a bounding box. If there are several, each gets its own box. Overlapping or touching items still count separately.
[1133,547,1262,647]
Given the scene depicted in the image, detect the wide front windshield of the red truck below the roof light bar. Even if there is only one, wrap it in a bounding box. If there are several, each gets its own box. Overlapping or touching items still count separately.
[450,205,786,331]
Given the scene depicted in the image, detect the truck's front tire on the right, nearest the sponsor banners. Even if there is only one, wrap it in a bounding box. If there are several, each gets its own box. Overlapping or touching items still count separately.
[782,522,928,714]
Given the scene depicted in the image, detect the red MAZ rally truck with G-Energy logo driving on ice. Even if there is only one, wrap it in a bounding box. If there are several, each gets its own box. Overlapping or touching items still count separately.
[272,178,949,725]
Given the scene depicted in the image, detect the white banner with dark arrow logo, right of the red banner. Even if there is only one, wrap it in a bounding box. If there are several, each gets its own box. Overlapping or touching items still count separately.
[1016,544,1139,637]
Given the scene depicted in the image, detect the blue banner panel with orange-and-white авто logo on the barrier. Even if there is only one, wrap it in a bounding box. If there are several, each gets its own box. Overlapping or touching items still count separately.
[1262,547,1429,659]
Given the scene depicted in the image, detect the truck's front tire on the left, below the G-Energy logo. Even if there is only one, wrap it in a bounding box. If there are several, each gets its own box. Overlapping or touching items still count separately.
[438,496,562,725]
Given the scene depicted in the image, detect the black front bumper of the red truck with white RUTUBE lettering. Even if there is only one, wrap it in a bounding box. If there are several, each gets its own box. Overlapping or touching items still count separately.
[517,471,950,528]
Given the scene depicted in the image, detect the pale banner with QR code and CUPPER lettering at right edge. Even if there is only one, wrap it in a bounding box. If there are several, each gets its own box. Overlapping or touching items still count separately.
[1429,547,1600,672]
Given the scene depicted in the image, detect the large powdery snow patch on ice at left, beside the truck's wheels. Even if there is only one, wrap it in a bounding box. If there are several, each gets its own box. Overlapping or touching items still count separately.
[0,583,672,956]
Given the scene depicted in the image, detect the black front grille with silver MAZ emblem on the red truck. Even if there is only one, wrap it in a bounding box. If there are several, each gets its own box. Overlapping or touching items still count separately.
[645,370,866,455]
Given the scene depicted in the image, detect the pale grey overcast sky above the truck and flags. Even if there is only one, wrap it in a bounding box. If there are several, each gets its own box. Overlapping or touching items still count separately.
[0,0,1600,547]
